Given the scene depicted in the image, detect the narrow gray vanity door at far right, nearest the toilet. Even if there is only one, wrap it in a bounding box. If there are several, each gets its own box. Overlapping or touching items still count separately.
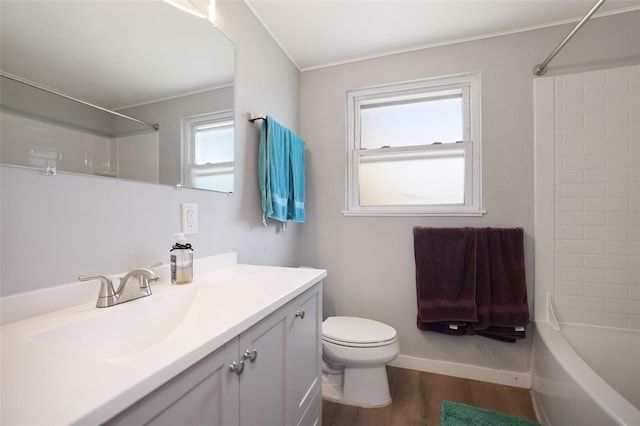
[292,284,322,421]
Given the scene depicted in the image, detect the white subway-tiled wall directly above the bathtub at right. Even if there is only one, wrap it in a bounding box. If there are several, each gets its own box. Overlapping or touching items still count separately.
[554,65,640,329]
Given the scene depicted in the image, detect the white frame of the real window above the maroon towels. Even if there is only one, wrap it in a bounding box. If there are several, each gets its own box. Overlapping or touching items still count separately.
[343,72,486,216]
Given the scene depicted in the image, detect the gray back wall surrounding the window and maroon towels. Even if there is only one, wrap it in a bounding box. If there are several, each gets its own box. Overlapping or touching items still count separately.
[300,13,640,372]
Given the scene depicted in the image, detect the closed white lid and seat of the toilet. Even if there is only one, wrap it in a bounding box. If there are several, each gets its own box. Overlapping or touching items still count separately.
[322,317,396,344]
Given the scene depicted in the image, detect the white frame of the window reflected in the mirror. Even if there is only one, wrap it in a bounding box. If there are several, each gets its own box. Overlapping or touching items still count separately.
[182,110,234,190]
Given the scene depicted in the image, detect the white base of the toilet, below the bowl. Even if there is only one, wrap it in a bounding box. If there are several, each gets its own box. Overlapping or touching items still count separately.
[322,365,391,408]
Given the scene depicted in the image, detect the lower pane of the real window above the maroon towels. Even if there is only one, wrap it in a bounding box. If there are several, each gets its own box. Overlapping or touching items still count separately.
[359,149,464,206]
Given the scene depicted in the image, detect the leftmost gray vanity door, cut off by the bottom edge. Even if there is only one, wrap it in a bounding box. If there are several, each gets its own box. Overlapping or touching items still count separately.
[107,339,239,426]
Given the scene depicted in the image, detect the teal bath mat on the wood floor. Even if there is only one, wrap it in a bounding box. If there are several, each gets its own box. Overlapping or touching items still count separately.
[440,401,540,426]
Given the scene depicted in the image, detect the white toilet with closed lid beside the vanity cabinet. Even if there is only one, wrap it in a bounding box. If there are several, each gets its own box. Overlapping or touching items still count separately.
[322,317,400,407]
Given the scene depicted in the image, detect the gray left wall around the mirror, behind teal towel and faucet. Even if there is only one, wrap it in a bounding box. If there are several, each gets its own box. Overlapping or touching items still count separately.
[0,1,301,295]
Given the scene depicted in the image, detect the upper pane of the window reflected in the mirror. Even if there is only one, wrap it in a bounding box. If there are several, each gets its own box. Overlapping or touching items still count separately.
[195,126,233,165]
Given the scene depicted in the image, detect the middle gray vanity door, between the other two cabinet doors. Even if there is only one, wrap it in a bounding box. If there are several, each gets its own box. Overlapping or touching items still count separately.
[240,309,293,426]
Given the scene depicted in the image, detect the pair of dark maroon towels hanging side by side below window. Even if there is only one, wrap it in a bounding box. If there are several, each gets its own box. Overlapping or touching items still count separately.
[413,227,529,342]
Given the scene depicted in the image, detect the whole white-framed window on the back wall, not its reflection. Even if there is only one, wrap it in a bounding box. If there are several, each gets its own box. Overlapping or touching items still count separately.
[344,73,484,216]
